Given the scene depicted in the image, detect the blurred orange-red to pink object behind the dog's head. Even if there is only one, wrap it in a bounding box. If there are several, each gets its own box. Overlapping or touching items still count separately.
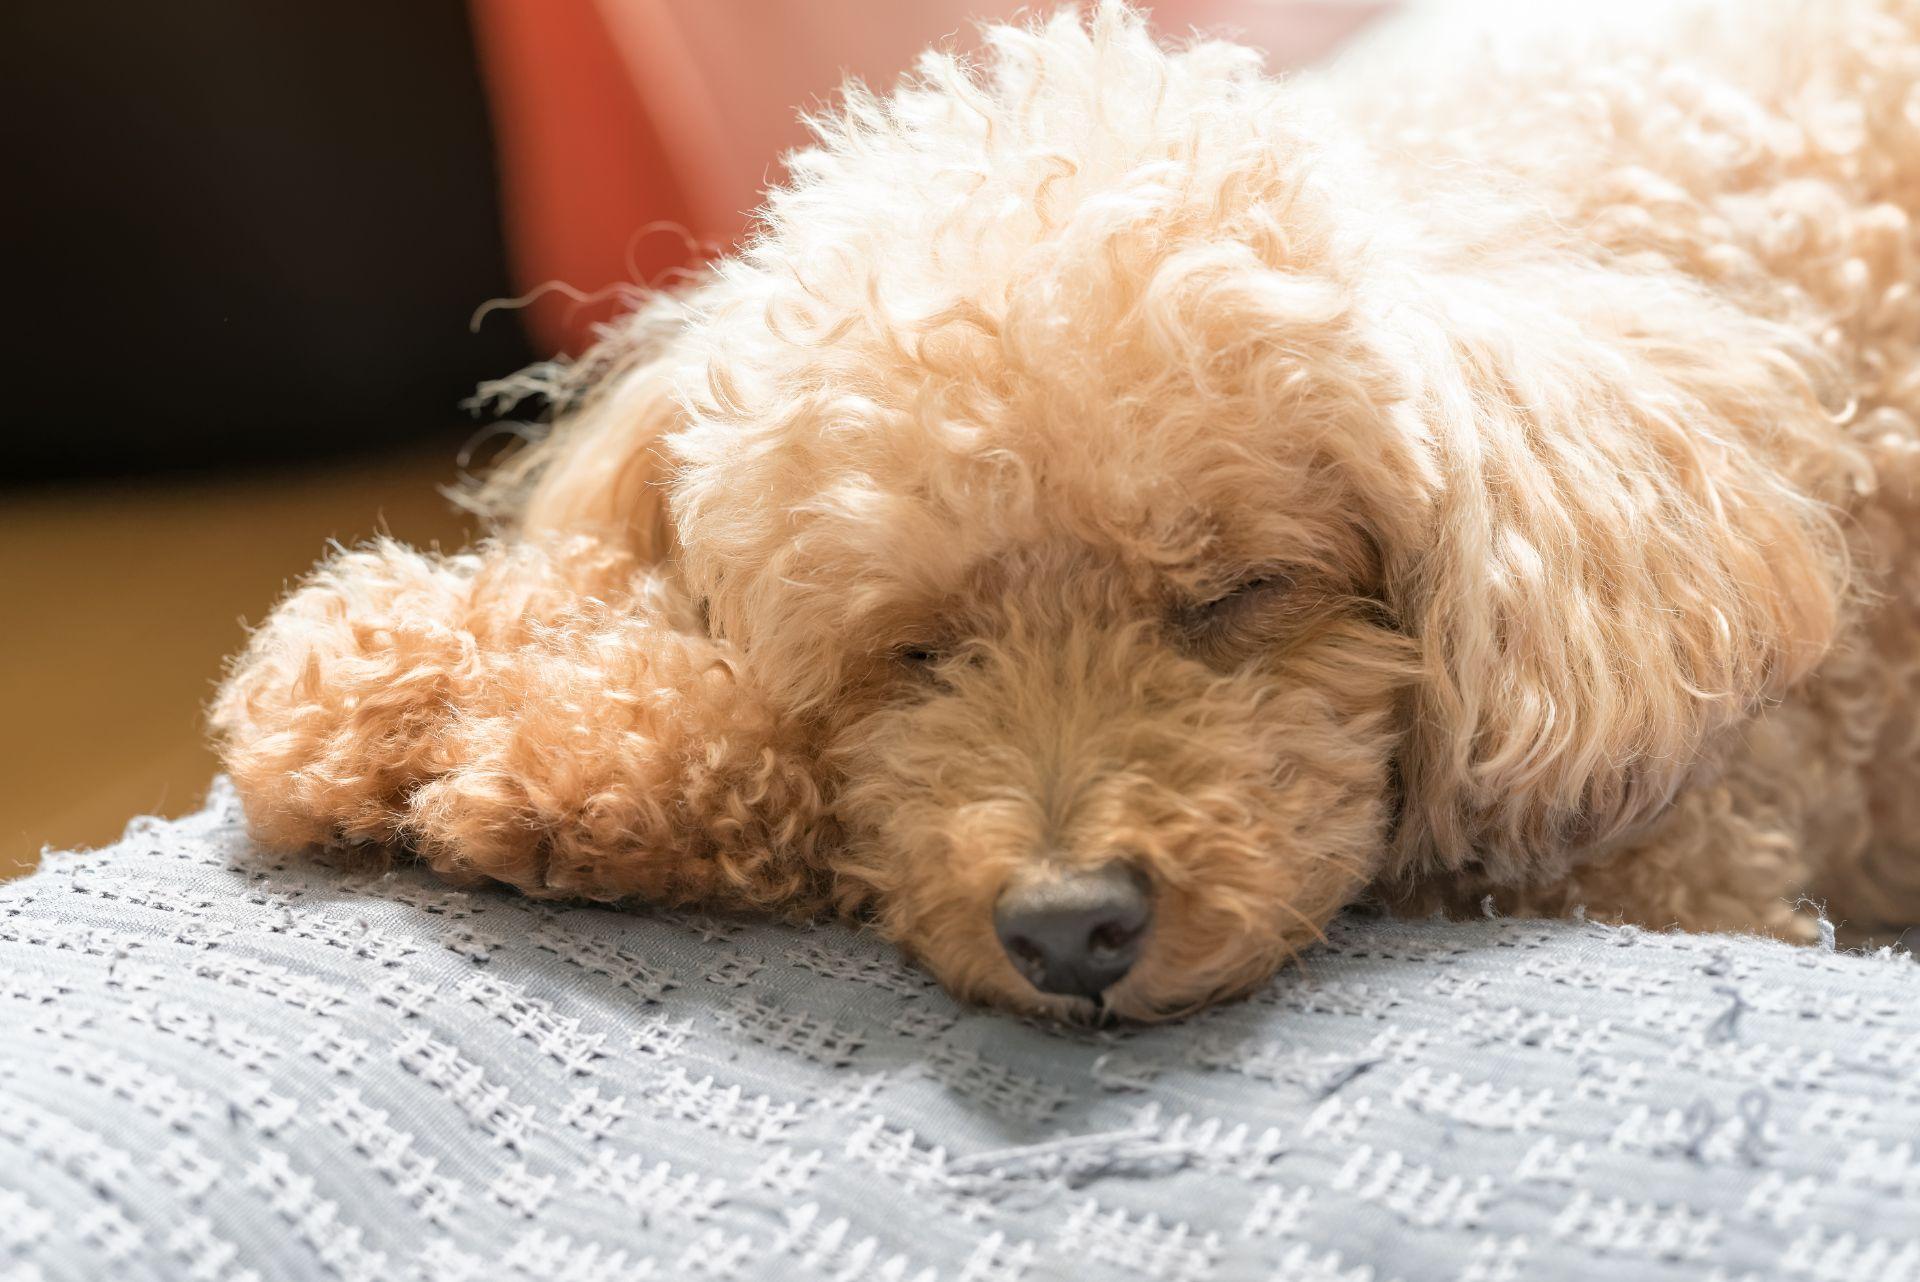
[472,0,1394,351]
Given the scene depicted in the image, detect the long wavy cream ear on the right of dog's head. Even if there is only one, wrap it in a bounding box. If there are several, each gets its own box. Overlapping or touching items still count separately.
[1390,265,1855,881]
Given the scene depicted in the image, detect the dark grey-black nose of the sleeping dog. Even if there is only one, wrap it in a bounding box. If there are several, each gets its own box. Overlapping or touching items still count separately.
[993,864,1154,998]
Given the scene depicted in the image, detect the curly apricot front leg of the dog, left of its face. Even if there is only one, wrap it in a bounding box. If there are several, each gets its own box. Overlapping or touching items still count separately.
[213,541,828,910]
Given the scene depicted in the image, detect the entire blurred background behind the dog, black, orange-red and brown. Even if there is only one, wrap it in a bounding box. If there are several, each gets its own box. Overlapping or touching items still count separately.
[0,0,1398,875]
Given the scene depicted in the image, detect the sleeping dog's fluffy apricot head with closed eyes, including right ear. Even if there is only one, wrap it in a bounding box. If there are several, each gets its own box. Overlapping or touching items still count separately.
[533,6,1839,1017]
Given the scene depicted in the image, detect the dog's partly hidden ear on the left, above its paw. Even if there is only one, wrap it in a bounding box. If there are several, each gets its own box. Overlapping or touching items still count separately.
[476,296,685,562]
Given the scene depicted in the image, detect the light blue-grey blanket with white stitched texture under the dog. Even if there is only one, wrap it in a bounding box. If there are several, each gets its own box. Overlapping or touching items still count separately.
[0,789,1920,1282]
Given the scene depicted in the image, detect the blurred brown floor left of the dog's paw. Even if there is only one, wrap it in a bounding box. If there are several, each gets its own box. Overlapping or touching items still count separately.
[0,449,468,877]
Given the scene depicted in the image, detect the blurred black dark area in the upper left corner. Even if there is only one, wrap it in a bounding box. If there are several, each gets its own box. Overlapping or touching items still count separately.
[0,0,528,486]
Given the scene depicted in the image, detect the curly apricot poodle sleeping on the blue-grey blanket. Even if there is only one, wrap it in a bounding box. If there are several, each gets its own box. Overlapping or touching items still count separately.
[211,0,1920,1019]
